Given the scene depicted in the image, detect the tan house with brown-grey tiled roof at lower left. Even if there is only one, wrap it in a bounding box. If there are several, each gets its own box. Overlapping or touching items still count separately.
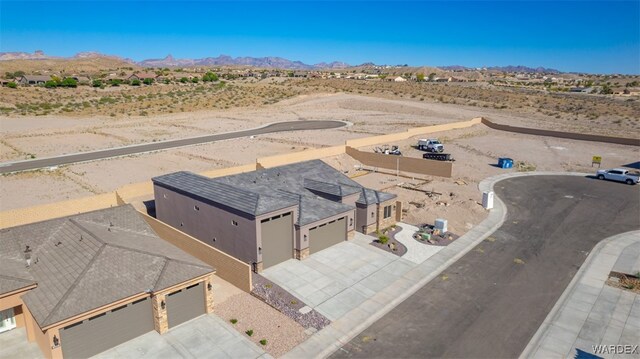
[0,205,215,358]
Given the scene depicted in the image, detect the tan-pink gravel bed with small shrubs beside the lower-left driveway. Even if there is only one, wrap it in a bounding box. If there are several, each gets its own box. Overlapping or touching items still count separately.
[215,292,308,357]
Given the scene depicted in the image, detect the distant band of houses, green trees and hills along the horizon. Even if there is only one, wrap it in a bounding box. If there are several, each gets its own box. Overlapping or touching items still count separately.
[0,53,640,96]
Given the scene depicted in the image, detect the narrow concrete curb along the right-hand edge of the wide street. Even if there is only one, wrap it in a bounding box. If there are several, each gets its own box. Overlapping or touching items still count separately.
[519,230,640,359]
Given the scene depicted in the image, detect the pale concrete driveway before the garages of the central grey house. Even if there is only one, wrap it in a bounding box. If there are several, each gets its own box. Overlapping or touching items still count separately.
[262,233,416,321]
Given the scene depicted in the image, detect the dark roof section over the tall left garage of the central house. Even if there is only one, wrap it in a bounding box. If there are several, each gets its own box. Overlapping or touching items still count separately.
[152,171,297,216]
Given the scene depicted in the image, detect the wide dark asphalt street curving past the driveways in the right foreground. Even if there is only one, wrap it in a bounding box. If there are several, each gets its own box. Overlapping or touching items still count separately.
[333,176,640,358]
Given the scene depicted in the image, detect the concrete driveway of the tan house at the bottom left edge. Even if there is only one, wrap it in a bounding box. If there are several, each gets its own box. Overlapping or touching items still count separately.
[93,314,271,359]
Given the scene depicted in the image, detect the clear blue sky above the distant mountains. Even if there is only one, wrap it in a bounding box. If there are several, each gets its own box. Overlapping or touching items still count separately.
[0,0,640,74]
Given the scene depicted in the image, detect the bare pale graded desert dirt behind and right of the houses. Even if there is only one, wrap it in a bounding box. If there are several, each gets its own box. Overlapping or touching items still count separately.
[0,93,640,234]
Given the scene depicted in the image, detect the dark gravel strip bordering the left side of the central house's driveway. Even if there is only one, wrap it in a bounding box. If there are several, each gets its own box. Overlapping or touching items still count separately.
[251,273,331,331]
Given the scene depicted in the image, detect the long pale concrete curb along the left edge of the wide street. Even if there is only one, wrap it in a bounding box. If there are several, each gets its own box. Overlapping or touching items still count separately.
[283,172,591,358]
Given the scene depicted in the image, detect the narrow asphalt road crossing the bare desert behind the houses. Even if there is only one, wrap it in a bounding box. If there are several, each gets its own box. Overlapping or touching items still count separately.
[0,121,346,173]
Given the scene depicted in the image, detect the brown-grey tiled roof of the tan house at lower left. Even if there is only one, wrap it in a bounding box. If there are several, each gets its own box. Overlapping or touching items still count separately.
[0,205,214,327]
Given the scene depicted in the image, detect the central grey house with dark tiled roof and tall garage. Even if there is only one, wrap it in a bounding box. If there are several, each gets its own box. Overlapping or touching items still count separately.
[153,160,400,272]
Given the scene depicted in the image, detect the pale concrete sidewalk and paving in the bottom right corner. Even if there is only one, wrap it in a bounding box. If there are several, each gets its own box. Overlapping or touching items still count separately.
[521,231,640,358]
